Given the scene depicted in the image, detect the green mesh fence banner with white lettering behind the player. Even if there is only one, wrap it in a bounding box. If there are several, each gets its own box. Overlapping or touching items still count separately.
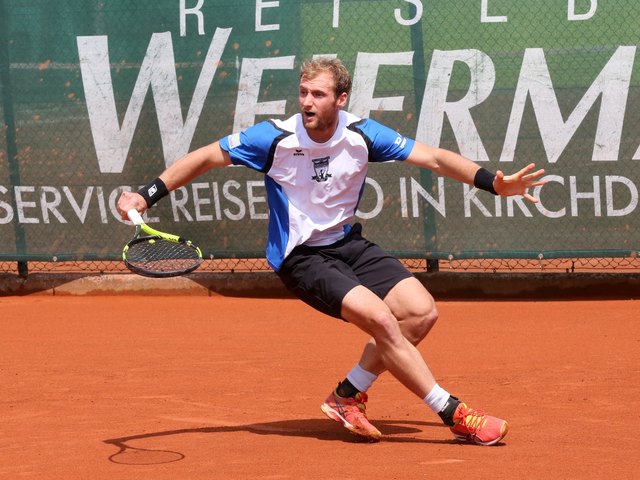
[0,0,640,271]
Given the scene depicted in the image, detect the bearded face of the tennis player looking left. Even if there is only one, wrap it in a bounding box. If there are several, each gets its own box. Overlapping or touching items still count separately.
[298,72,347,143]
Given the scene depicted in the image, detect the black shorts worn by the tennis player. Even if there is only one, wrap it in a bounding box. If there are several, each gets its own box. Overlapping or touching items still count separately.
[278,223,412,318]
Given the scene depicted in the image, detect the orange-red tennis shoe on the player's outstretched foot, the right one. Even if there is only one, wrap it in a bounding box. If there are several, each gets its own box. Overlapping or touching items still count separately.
[451,403,509,445]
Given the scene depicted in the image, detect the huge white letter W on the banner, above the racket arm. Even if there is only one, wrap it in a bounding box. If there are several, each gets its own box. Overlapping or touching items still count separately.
[77,29,231,173]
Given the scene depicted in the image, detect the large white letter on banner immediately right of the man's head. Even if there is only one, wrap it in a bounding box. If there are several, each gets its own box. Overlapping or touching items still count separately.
[349,52,413,118]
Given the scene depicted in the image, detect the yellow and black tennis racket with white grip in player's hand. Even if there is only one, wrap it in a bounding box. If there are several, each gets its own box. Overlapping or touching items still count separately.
[122,209,202,278]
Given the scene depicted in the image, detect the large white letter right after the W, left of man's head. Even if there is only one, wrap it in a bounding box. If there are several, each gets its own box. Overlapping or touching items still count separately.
[233,56,295,132]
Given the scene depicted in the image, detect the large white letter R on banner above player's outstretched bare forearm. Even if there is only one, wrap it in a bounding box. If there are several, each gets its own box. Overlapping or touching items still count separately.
[416,50,496,161]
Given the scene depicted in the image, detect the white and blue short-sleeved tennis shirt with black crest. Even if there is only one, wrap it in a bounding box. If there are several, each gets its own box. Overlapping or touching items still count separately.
[220,111,415,271]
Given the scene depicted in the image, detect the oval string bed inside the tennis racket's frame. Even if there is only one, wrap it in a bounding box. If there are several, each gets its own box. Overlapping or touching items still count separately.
[126,237,201,272]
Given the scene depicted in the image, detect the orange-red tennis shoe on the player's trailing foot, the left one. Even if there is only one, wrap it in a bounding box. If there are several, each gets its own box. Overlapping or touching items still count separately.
[320,392,382,442]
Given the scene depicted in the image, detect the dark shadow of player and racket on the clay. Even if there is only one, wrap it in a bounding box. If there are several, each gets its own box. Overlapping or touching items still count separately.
[104,418,456,465]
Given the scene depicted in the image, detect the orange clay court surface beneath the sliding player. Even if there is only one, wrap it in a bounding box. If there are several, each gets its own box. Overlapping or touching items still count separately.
[0,295,640,480]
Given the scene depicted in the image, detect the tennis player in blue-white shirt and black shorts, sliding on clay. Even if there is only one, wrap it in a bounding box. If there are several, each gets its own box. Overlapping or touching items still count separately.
[118,58,544,445]
